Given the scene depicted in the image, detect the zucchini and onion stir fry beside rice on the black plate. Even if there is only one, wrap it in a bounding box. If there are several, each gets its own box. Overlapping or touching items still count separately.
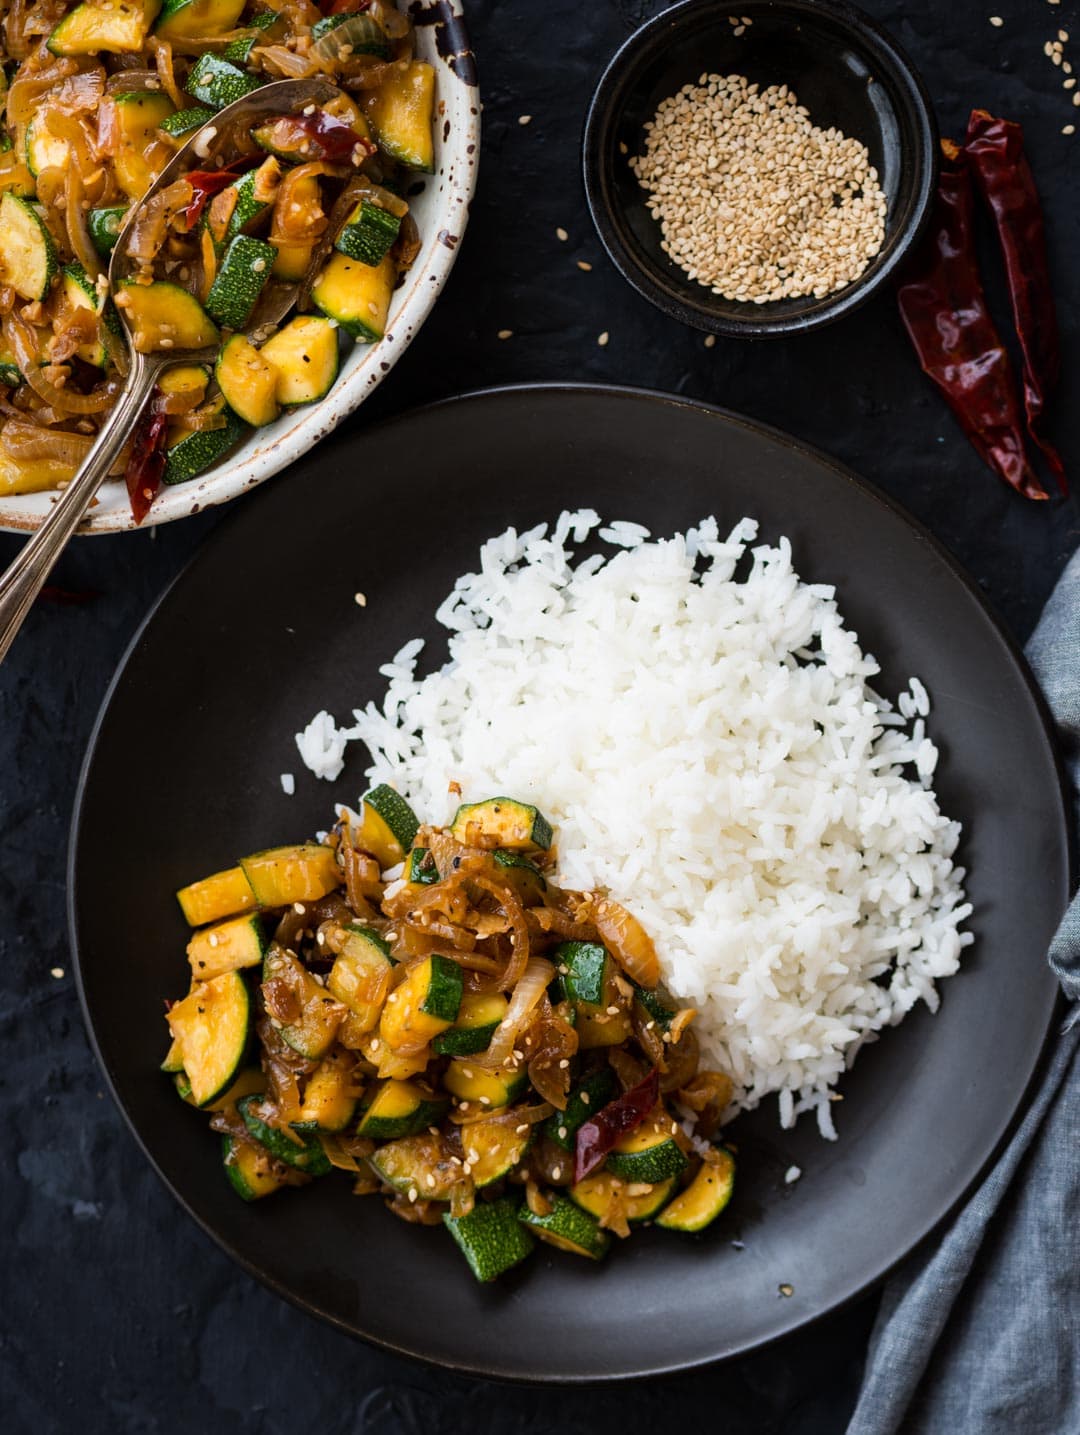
[162,786,734,1281]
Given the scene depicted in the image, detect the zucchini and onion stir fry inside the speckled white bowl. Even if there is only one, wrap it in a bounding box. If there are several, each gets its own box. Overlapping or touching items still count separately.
[0,0,435,521]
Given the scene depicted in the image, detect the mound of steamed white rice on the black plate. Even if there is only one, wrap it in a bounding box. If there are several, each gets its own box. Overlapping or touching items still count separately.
[297,511,972,1137]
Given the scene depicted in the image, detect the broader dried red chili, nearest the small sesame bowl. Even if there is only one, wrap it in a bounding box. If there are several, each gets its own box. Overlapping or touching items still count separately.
[898,139,1048,498]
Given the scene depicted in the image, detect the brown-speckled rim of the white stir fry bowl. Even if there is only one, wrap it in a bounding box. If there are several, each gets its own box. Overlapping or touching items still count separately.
[0,0,480,534]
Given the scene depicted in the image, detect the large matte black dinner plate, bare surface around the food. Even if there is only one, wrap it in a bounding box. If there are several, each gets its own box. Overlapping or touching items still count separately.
[69,386,1070,1380]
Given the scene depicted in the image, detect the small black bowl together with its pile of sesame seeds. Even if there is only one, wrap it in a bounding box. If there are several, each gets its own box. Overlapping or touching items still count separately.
[584,0,937,337]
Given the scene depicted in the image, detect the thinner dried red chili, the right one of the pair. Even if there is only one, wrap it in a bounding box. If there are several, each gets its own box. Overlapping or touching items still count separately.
[964,109,1069,494]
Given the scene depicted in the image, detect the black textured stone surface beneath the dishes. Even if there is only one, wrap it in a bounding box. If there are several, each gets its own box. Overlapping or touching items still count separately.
[0,0,1080,1435]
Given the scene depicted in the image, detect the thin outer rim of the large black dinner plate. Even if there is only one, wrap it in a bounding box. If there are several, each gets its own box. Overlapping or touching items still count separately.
[66,382,1077,1386]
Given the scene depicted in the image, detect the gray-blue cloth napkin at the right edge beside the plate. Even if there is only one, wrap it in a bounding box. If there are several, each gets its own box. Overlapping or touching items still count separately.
[848,552,1080,1435]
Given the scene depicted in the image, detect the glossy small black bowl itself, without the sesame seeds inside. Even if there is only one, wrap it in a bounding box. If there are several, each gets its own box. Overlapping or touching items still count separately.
[584,0,938,339]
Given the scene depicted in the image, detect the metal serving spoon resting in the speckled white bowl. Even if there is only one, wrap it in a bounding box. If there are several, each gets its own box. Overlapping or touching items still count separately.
[0,79,340,662]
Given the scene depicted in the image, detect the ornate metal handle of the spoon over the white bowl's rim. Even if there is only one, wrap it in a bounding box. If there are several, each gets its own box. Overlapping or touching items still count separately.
[0,354,158,663]
